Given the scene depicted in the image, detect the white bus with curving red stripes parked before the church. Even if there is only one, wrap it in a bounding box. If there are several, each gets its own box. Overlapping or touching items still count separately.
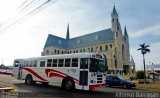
[12,53,107,90]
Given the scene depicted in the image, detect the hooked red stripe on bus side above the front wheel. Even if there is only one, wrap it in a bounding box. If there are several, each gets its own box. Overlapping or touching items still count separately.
[45,69,79,84]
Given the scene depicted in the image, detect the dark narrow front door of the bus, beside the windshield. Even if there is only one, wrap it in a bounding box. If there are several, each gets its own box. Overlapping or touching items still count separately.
[79,58,89,90]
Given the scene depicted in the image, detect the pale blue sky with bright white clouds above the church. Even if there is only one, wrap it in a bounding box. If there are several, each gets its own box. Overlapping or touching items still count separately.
[0,0,160,69]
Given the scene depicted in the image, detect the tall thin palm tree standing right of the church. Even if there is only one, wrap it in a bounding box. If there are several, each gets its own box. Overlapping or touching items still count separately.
[137,43,150,83]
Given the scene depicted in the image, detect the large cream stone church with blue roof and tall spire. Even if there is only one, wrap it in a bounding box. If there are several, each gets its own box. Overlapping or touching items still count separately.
[41,5,135,74]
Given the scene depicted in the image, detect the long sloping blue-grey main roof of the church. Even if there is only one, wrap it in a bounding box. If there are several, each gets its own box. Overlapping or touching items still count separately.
[44,28,114,49]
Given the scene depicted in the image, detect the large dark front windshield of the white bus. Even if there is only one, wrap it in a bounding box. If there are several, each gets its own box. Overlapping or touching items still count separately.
[89,58,107,72]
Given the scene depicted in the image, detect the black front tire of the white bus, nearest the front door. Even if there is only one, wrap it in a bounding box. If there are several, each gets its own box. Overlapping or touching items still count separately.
[62,78,75,90]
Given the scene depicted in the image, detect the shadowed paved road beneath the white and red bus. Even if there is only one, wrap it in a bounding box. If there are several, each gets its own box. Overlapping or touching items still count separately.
[0,75,155,98]
